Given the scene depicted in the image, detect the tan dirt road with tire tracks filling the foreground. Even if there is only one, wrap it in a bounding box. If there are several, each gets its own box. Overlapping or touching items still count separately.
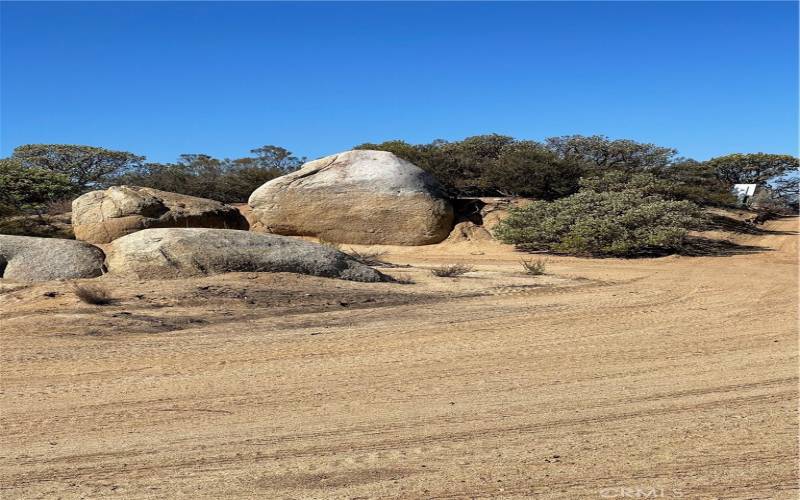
[0,219,798,499]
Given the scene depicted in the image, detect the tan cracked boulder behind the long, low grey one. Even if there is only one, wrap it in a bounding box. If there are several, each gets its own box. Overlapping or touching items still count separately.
[72,186,248,243]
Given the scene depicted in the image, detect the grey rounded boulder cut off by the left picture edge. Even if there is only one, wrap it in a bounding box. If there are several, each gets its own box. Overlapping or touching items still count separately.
[0,234,105,281]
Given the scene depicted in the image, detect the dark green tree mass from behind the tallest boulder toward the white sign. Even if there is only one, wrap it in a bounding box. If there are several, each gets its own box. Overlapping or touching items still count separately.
[356,134,735,206]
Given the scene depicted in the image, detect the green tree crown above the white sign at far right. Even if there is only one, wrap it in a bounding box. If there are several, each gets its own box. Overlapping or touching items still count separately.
[706,153,800,185]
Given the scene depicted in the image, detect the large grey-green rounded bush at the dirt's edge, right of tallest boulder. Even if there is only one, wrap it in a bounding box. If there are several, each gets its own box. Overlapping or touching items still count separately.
[495,189,701,257]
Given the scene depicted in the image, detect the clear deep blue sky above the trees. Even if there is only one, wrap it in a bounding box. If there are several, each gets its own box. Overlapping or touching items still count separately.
[0,2,798,161]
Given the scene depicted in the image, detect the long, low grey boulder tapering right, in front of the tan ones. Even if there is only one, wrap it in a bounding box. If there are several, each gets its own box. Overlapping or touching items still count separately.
[107,228,388,282]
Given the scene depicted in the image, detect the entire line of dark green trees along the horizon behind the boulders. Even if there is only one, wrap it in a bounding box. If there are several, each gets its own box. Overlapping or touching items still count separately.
[0,134,798,216]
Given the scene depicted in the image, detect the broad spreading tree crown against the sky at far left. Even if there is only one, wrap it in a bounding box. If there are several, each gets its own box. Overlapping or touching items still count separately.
[11,144,144,193]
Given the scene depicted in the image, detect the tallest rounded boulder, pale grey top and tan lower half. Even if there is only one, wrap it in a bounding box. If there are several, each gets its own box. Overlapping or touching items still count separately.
[249,150,453,245]
